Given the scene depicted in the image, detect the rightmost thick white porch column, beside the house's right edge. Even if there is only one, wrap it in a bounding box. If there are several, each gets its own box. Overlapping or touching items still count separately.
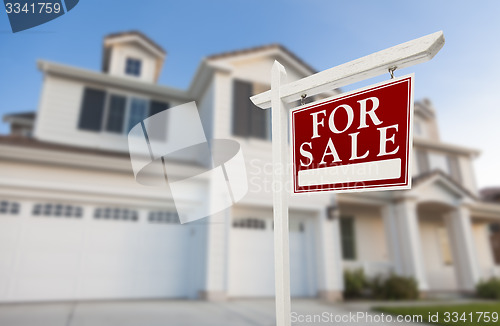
[445,206,480,292]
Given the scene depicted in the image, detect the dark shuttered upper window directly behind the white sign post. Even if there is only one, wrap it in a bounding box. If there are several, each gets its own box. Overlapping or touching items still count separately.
[233,80,271,139]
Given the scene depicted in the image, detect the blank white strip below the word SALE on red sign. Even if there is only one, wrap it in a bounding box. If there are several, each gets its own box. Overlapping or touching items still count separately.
[298,158,401,187]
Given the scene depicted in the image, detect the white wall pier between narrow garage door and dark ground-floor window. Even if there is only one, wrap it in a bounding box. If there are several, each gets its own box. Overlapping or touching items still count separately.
[316,209,344,301]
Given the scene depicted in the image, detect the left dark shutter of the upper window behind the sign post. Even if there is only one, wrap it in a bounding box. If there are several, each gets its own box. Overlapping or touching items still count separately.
[233,80,253,137]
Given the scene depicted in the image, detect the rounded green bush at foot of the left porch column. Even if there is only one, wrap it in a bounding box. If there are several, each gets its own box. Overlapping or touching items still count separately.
[370,274,418,300]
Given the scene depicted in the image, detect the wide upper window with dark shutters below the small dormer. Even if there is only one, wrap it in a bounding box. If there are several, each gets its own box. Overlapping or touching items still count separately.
[78,88,170,134]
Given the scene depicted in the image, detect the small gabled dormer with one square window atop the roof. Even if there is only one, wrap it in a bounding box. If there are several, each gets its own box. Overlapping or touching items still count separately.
[102,31,167,83]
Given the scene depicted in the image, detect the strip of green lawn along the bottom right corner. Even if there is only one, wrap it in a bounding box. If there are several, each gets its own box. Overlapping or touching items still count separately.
[374,303,500,326]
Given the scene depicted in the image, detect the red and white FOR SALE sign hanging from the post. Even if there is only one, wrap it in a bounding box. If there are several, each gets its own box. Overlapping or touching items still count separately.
[290,75,414,193]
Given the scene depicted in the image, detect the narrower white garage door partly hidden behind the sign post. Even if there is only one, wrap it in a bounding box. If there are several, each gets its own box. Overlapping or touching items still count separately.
[228,212,317,297]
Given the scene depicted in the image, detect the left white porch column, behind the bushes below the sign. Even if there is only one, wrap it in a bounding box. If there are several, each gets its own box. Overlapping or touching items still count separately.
[394,198,429,291]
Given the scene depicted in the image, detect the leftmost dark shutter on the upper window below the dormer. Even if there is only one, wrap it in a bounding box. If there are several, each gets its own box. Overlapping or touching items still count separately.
[78,88,106,131]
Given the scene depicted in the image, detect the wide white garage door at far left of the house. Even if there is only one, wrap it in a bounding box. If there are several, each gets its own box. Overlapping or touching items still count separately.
[0,201,189,302]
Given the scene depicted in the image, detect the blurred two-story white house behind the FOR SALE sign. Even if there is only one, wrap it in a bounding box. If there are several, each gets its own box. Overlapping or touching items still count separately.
[0,32,500,302]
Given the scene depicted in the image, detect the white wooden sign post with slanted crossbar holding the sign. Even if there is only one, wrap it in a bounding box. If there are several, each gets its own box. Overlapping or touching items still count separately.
[250,31,444,326]
